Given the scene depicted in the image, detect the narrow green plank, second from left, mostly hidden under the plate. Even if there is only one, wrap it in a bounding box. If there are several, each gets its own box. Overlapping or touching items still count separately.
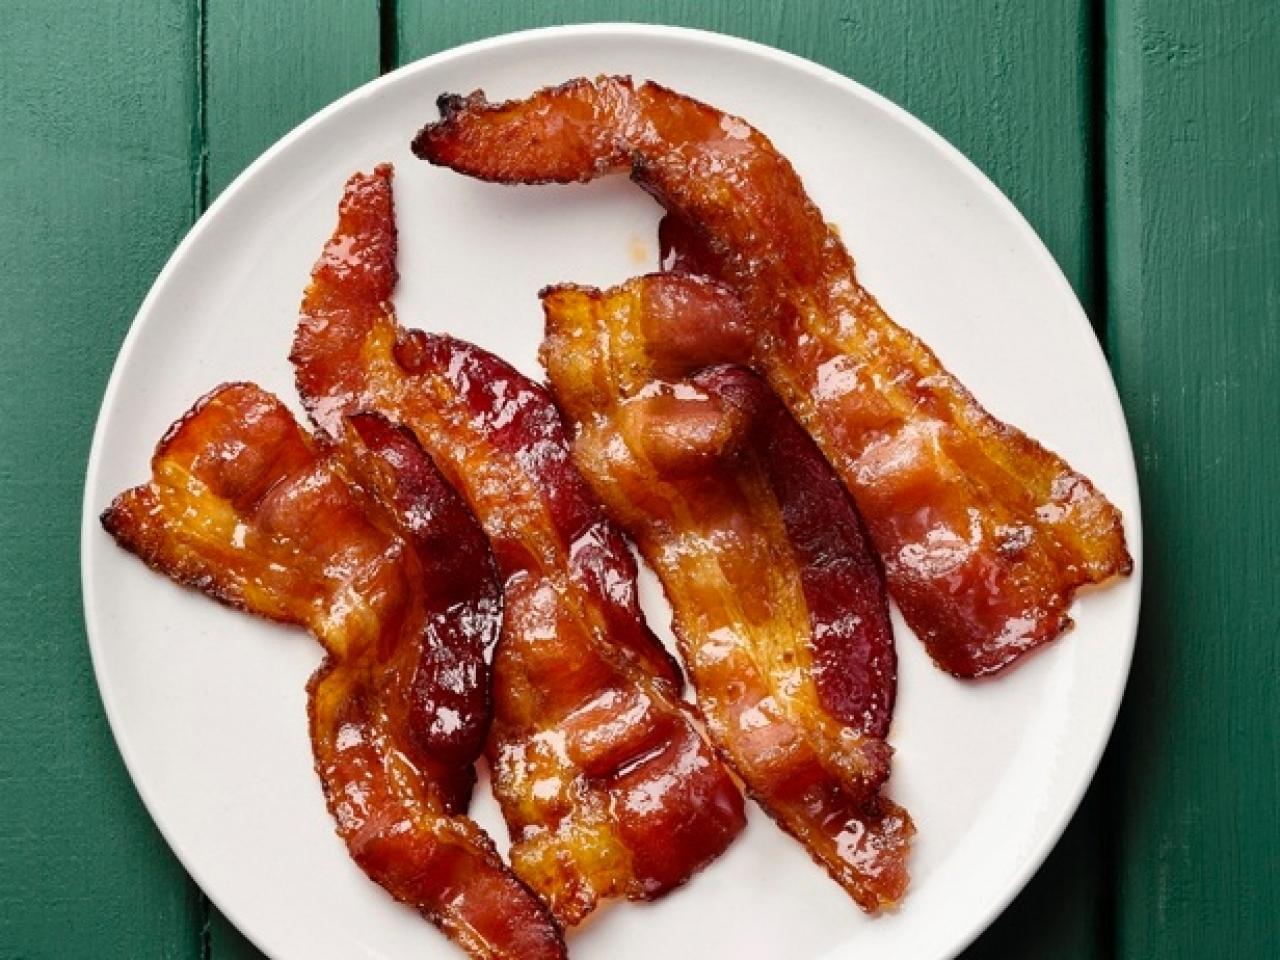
[202,0,380,960]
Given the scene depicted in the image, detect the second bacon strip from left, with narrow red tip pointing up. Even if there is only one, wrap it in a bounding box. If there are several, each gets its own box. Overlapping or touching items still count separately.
[293,166,744,924]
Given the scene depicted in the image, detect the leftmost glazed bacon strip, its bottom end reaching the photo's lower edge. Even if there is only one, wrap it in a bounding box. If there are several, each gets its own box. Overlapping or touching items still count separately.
[102,384,564,960]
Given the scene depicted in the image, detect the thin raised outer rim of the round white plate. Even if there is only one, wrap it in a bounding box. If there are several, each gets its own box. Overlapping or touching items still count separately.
[79,20,1144,960]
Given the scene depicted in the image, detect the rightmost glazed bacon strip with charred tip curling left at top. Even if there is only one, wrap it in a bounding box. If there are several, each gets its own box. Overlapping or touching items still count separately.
[413,77,1132,677]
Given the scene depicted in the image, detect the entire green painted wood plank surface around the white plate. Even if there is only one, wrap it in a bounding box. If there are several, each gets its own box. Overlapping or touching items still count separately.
[0,0,1280,960]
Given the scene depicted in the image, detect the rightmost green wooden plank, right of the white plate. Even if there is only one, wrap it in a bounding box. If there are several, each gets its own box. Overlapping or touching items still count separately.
[1106,0,1280,959]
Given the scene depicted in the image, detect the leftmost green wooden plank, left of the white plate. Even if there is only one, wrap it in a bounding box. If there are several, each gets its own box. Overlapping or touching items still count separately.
[0,0,200,960]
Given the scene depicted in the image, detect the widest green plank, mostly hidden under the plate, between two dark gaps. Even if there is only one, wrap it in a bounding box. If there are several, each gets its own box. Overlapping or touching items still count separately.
[394,0,1110,960]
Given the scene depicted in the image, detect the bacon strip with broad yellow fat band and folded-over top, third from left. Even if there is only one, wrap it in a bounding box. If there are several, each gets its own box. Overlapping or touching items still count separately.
[541,274,914,910]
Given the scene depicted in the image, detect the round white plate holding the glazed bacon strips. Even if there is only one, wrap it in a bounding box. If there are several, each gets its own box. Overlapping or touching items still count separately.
[83,26,1140,960]
